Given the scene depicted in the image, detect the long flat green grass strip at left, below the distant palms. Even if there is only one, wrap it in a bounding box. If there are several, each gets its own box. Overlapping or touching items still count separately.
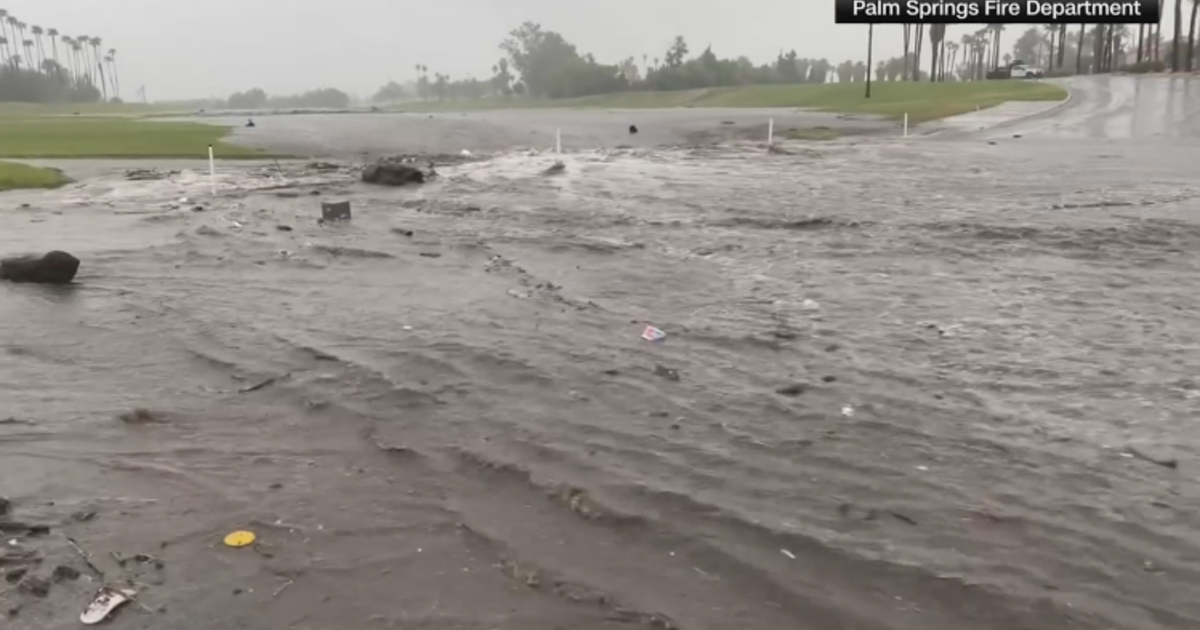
[0,113,272,160]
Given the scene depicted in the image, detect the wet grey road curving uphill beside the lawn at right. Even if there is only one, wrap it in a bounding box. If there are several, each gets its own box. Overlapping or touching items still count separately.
[983,76,1200,145]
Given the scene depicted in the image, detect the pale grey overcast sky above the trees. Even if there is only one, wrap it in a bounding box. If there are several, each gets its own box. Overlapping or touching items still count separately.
[0,0,1168,100]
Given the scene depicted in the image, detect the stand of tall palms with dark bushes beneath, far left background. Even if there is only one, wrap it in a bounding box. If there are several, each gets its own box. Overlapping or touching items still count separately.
[0,8,120,103]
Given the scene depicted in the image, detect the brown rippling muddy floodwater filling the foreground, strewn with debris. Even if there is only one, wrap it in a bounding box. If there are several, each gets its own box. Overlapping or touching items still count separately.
[0,140,1200,630]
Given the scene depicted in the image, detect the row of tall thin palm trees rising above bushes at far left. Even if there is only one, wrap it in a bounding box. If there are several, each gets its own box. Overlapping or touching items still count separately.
[0,8,121,101]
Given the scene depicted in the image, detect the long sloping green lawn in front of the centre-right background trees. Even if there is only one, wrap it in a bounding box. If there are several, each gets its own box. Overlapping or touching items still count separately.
[394,80,1067,122]
